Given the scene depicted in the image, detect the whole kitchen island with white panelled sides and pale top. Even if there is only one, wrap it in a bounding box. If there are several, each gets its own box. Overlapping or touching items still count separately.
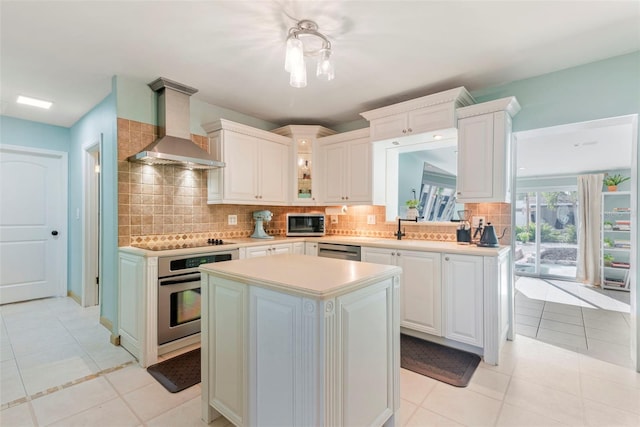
[200,255,401,426]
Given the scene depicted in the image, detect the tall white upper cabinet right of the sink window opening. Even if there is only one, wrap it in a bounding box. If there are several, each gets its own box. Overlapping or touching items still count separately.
[456,97,520,203]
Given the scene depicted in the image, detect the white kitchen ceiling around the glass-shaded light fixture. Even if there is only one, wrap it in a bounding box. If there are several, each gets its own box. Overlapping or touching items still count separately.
[0,0,640,127]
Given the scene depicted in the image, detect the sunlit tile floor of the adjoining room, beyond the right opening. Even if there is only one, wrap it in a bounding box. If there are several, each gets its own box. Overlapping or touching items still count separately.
[515,277,633,367]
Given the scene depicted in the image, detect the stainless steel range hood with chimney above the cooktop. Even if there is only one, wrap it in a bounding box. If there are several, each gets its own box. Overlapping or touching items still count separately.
[127,77,225,169]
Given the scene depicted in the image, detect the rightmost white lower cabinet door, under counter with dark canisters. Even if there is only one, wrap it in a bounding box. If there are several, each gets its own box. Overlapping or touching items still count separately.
[442,254,484,347]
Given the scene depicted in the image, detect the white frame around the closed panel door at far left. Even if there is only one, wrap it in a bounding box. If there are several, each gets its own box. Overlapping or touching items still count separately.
[0,144,69,297]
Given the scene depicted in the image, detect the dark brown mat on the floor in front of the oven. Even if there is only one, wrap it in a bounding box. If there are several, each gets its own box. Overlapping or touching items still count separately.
[147,348,200,393]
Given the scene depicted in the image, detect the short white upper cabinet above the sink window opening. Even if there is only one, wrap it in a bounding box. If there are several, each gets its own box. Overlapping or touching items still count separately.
[360,87,473,141]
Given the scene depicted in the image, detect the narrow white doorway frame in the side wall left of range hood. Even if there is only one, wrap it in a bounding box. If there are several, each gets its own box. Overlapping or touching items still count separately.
[81,135,102,307]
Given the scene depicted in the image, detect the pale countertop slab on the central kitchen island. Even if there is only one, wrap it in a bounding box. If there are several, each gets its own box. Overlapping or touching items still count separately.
[200,254,402,299]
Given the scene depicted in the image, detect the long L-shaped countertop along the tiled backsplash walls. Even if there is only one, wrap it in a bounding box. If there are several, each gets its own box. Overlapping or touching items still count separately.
[119,236,510,257]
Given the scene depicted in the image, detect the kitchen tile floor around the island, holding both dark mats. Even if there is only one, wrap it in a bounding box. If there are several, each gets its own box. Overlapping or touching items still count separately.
[0,299,640,427]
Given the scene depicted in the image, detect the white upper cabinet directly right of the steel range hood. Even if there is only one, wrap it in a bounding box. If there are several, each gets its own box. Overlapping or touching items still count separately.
[203,120,291,205]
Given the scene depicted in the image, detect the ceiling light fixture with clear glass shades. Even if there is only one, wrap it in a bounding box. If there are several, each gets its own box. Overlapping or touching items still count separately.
[284,19,335,88]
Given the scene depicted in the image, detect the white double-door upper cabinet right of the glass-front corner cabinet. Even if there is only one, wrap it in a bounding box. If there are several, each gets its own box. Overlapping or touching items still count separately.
[318,129,372,205]
